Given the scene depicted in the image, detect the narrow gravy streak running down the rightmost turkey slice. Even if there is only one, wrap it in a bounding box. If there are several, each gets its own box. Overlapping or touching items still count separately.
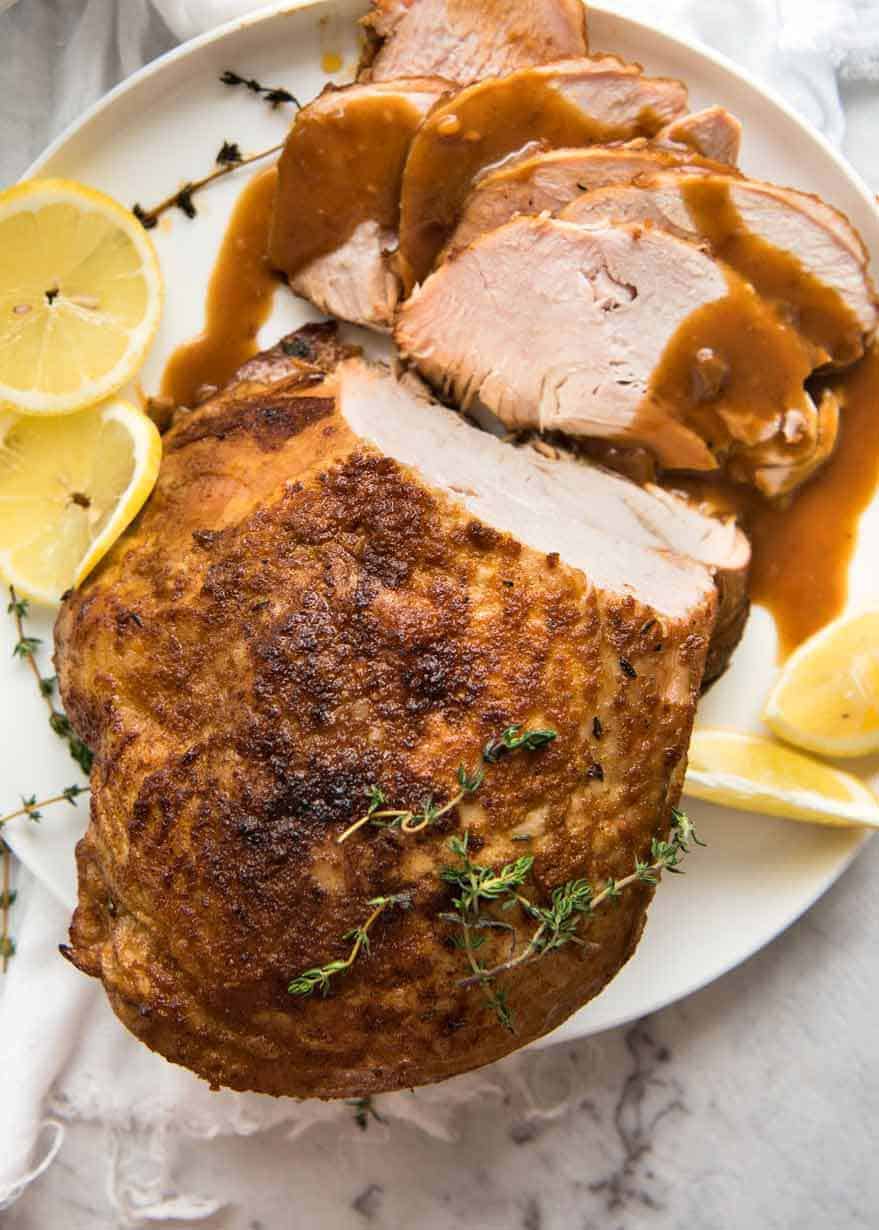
[681,176,862,367]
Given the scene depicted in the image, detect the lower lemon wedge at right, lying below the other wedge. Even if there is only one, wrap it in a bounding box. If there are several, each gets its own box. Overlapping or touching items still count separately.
[684,731,879,828]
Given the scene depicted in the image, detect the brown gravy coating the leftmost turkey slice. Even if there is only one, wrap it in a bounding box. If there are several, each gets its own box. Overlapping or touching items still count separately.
[270,82,434,277]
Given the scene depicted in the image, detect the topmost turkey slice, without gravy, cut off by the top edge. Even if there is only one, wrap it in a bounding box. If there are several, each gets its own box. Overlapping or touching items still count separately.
[360,0,589,85]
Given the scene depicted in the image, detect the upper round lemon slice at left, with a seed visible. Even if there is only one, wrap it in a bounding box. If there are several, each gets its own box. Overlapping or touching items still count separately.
[0,180,162,415]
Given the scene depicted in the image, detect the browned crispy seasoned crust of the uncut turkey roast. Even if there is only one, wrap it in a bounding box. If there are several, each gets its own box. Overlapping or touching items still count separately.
[57,329,714,1097]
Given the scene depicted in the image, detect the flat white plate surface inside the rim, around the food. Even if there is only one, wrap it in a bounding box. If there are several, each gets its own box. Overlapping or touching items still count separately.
[0,0,879,1041]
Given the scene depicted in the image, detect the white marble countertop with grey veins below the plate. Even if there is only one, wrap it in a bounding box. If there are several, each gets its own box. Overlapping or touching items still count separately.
[0,11,879,1230]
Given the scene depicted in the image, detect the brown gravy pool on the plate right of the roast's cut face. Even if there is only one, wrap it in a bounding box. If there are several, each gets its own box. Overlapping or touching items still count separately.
[666,346,879,654]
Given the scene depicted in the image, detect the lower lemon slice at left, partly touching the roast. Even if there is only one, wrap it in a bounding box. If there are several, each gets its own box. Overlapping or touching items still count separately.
[0,399,162,603]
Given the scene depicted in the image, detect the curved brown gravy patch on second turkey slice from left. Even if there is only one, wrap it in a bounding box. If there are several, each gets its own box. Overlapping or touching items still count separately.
[400,69,670,289]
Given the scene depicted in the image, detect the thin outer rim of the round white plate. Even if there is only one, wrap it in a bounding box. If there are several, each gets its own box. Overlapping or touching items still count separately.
[7,0,879,1049]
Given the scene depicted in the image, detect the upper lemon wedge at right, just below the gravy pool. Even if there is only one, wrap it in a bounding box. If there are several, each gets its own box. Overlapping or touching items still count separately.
[763,606,879,756]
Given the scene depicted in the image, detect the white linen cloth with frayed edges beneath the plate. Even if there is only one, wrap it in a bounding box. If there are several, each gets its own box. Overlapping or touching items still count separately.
[0,0,879,1224]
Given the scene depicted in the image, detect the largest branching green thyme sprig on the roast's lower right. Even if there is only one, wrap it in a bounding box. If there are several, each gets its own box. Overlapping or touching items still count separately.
[440,808,704,1032]
